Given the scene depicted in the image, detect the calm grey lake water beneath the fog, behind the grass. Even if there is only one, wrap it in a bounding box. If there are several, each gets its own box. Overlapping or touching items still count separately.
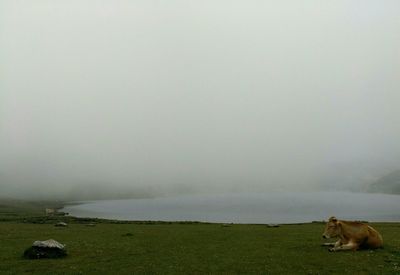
[63,192,400,223]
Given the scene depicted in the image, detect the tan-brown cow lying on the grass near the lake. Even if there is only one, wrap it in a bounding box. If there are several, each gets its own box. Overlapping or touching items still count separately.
[322,217,383,251]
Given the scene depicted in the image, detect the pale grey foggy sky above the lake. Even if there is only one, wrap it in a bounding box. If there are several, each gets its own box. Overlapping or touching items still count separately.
[0,0,400,199]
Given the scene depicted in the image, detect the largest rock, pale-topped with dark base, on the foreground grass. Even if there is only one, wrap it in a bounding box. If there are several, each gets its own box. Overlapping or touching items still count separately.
[24,239,67,259]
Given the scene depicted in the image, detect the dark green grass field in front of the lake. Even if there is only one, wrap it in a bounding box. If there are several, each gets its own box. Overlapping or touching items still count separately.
[0,199,400,274]
